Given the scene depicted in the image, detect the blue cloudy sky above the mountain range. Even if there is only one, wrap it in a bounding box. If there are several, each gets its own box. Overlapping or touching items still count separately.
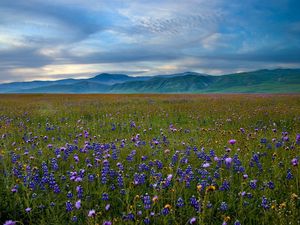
[0,0,300,82]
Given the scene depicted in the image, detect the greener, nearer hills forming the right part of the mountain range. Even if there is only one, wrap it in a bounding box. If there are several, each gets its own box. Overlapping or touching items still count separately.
[111,69,300,93]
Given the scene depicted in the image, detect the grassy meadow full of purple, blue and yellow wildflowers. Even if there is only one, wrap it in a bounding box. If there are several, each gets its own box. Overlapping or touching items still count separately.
[0,94,300,225]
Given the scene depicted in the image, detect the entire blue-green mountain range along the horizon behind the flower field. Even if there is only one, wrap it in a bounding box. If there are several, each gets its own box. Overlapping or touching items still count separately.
[0,69,300,93]
